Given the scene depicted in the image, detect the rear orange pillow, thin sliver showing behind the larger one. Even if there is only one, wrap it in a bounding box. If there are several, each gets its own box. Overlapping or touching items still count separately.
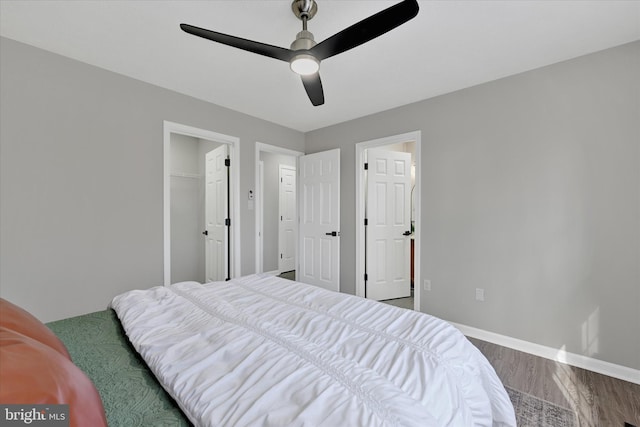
[0,298,71,360]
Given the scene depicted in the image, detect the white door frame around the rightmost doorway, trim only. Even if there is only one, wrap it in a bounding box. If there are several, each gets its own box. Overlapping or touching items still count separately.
[355,130,422,311]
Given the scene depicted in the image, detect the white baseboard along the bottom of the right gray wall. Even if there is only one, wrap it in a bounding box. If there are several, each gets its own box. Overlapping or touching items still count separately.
[449,322,640,384]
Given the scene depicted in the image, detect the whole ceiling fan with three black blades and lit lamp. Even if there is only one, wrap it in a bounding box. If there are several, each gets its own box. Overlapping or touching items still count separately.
[180,0,418,106]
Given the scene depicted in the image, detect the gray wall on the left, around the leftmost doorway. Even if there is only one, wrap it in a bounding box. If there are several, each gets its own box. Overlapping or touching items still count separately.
[0,38,304,321]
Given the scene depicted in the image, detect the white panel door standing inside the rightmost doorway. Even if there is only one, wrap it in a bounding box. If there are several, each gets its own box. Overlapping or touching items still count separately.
[366,149,411,301]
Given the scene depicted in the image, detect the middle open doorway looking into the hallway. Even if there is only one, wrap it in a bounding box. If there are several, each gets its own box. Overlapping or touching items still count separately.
[255,142,303,279]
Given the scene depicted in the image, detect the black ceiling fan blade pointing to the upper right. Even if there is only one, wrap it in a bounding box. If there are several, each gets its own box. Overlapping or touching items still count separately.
[309,0,419,61]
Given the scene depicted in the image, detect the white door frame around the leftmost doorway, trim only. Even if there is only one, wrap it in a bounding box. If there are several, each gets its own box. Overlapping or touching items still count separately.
[162,120,241,286]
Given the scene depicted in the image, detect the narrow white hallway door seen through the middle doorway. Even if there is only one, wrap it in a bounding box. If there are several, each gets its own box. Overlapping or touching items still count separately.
[278,165,298,272]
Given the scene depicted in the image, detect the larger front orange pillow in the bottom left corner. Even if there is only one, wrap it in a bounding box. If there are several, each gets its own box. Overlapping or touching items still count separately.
[0,327,107,427]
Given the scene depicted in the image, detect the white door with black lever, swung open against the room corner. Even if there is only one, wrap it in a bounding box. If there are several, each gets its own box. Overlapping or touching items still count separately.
[296,149,340,291]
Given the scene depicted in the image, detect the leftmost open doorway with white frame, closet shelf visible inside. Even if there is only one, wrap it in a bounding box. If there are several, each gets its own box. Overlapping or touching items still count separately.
[164,121,240,286]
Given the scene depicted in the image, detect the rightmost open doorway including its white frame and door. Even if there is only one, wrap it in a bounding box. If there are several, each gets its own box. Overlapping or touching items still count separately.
[356,132,420,311]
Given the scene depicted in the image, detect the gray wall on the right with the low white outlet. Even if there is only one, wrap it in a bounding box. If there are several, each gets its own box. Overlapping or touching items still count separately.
[305,42,640,369]
